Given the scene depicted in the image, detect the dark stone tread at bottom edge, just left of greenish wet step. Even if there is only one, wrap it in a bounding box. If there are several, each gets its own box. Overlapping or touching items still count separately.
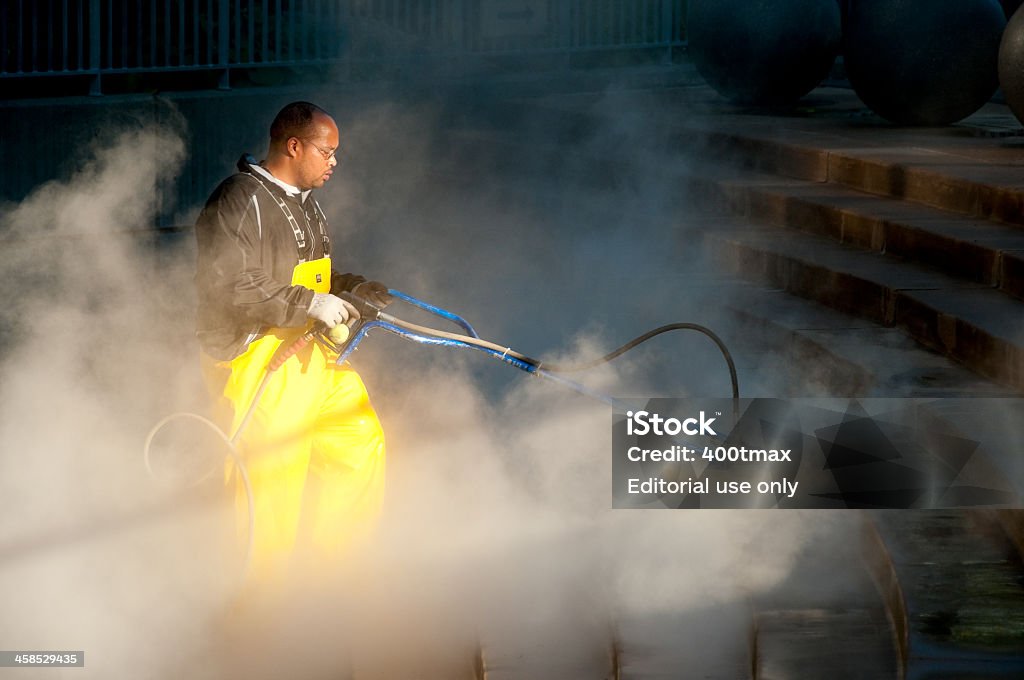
[754,607,898,680]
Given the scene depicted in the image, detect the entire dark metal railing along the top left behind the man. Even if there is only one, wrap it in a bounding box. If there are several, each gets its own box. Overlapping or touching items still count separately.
[0,0,686,93]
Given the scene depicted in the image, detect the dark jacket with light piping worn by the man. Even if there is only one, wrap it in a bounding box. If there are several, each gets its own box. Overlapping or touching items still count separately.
[196,156,366,359]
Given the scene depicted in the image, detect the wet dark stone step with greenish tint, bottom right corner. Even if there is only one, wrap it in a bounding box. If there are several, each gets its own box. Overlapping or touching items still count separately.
[872,510,1024,680]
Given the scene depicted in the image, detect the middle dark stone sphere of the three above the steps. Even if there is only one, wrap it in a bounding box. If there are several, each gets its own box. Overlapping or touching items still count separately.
[843,0,1007,125]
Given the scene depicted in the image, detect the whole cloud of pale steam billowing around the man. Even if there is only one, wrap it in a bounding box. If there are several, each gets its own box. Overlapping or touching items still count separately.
[0,87,847,679]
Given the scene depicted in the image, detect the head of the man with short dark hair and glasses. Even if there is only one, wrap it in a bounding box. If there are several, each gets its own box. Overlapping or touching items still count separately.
[266,101,339,190]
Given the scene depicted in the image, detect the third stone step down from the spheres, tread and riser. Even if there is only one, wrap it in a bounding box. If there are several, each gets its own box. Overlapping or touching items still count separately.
[707,220,1024,389]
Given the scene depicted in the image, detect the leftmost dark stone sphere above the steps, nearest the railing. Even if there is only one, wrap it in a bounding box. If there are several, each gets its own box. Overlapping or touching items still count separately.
[686,0,841,105]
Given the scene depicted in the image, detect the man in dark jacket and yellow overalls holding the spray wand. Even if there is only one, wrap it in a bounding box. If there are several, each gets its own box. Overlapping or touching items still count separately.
[196,101,389,582]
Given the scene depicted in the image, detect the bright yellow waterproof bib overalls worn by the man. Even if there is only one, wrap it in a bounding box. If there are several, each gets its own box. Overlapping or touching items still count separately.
[203,257,384,585]
